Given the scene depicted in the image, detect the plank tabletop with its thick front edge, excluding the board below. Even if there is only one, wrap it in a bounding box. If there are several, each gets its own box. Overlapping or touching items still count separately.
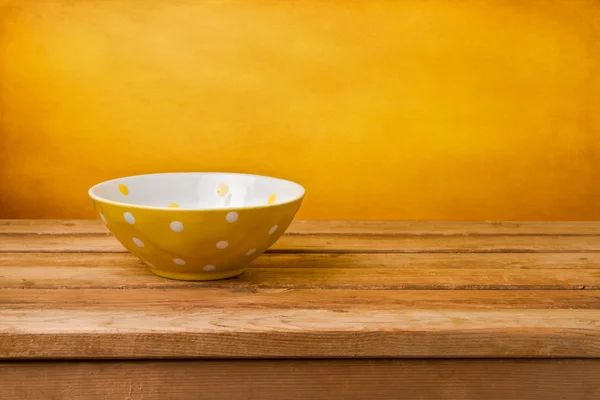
[0,222,600,359]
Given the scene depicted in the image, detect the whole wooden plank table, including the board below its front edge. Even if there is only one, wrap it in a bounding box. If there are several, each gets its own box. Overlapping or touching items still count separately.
[0,220,600,400]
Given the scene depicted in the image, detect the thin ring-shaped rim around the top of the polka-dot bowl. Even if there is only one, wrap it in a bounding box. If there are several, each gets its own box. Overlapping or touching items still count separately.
[88,171,306,212]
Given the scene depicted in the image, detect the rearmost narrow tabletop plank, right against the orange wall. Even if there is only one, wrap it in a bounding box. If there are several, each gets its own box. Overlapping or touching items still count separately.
[0,219,600,236]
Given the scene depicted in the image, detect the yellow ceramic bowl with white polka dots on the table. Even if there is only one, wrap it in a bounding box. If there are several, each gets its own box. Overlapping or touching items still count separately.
[89,173,304,280]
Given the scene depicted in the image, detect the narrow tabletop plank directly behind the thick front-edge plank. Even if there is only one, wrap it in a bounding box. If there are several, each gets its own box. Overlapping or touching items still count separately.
[0,288,600,313]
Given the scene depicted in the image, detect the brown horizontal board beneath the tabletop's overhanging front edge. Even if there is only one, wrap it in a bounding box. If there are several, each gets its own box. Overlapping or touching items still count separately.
[0,359,600,400]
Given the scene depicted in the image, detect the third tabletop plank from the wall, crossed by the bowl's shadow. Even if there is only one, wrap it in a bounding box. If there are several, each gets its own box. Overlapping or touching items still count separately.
[0,253,600,269]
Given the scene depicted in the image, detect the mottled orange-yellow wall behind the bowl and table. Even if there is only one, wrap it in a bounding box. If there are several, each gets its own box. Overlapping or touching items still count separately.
[0,0,600,219]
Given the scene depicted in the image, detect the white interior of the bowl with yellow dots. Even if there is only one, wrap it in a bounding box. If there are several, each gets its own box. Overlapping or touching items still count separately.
[90,172,304,209]
